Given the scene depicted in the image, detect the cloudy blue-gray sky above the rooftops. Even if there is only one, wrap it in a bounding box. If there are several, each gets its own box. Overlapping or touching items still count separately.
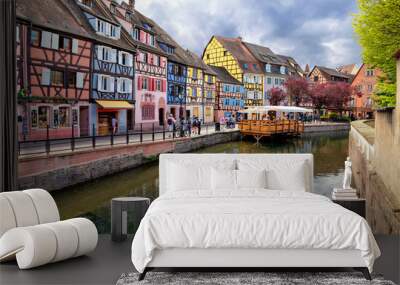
[136,0,361,67]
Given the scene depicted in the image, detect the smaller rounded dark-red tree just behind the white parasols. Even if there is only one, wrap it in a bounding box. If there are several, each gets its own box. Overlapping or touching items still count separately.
[284,76,310,106]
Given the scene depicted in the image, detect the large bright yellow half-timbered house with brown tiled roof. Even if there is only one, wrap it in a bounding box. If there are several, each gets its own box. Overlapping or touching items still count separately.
[203,36,264,106]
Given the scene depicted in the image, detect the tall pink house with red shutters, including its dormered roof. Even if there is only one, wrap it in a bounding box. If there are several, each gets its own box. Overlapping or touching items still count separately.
[102,0,167,128]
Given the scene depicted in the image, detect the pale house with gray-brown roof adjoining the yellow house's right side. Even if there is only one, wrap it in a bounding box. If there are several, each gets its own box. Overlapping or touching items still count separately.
[244,42,304,105]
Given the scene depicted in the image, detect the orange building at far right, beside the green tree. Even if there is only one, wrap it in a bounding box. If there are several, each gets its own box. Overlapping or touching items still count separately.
[350,64,382,119]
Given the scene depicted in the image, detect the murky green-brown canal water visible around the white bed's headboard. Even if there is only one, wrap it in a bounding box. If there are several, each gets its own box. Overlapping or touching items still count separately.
[53,132,349,233]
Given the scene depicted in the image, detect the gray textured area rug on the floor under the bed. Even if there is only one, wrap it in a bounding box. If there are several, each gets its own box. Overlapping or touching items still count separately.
[117,272,395,285]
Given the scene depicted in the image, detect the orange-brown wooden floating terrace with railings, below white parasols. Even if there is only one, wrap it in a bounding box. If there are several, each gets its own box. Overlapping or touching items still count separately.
[238,120,304,142]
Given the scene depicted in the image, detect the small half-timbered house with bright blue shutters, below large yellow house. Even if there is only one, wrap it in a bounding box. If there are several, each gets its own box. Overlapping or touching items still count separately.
[210,65,245,122]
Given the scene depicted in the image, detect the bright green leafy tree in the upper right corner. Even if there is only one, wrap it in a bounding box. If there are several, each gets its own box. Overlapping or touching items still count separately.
[353,0,400,107]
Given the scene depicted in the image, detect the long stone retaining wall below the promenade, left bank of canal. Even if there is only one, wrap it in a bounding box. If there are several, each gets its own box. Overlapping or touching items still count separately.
[18,131,240,191]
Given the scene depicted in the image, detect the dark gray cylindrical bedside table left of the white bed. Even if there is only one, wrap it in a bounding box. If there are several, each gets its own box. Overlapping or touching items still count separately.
[111,197,150,241]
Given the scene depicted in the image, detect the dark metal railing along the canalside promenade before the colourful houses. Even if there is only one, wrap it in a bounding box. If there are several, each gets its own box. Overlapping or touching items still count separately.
[18,123,224,157]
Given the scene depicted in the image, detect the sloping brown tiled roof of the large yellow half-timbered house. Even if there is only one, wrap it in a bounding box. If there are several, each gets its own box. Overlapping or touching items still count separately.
[215,36,263,74]
